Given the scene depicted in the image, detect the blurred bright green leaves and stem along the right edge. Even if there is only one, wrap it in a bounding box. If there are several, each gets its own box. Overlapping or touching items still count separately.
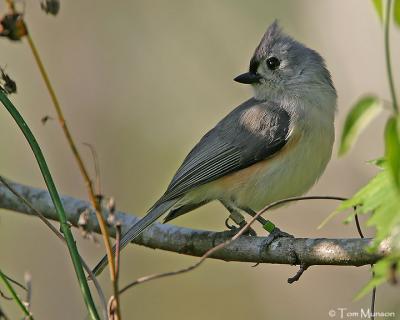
[336,0,400,298]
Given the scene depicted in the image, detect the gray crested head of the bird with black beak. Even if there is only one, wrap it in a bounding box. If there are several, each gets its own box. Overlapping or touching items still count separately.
[234,21,335,100]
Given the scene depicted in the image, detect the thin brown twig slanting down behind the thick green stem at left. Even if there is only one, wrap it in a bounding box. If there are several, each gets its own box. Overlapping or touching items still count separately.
[0,176,107,319]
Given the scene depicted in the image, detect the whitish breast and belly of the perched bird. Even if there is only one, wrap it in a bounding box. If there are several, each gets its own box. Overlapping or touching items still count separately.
[225,102,335,210]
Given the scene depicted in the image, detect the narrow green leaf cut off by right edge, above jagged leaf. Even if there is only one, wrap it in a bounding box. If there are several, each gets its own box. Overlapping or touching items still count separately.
[385,116,400,191]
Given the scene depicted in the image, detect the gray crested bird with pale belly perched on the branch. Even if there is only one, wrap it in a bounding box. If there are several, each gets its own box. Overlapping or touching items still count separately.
[93,21,336,274]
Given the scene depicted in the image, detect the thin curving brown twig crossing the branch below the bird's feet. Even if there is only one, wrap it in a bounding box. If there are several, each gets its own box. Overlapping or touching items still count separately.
[119,196,345,294]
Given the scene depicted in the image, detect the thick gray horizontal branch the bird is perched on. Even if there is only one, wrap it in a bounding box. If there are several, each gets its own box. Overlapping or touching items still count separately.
[0,180,389,266]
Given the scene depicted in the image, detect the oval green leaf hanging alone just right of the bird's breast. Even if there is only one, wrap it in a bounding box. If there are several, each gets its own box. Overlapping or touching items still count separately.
[339,96,381,156]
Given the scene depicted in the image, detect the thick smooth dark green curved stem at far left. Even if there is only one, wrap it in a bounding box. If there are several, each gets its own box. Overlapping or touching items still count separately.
[0,90,99,319]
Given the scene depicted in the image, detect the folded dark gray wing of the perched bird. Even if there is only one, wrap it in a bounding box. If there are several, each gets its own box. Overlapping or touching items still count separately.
[155,99,290,205]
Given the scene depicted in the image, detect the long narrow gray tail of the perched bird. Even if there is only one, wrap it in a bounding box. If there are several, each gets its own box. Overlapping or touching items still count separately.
[93,199,178,276]
